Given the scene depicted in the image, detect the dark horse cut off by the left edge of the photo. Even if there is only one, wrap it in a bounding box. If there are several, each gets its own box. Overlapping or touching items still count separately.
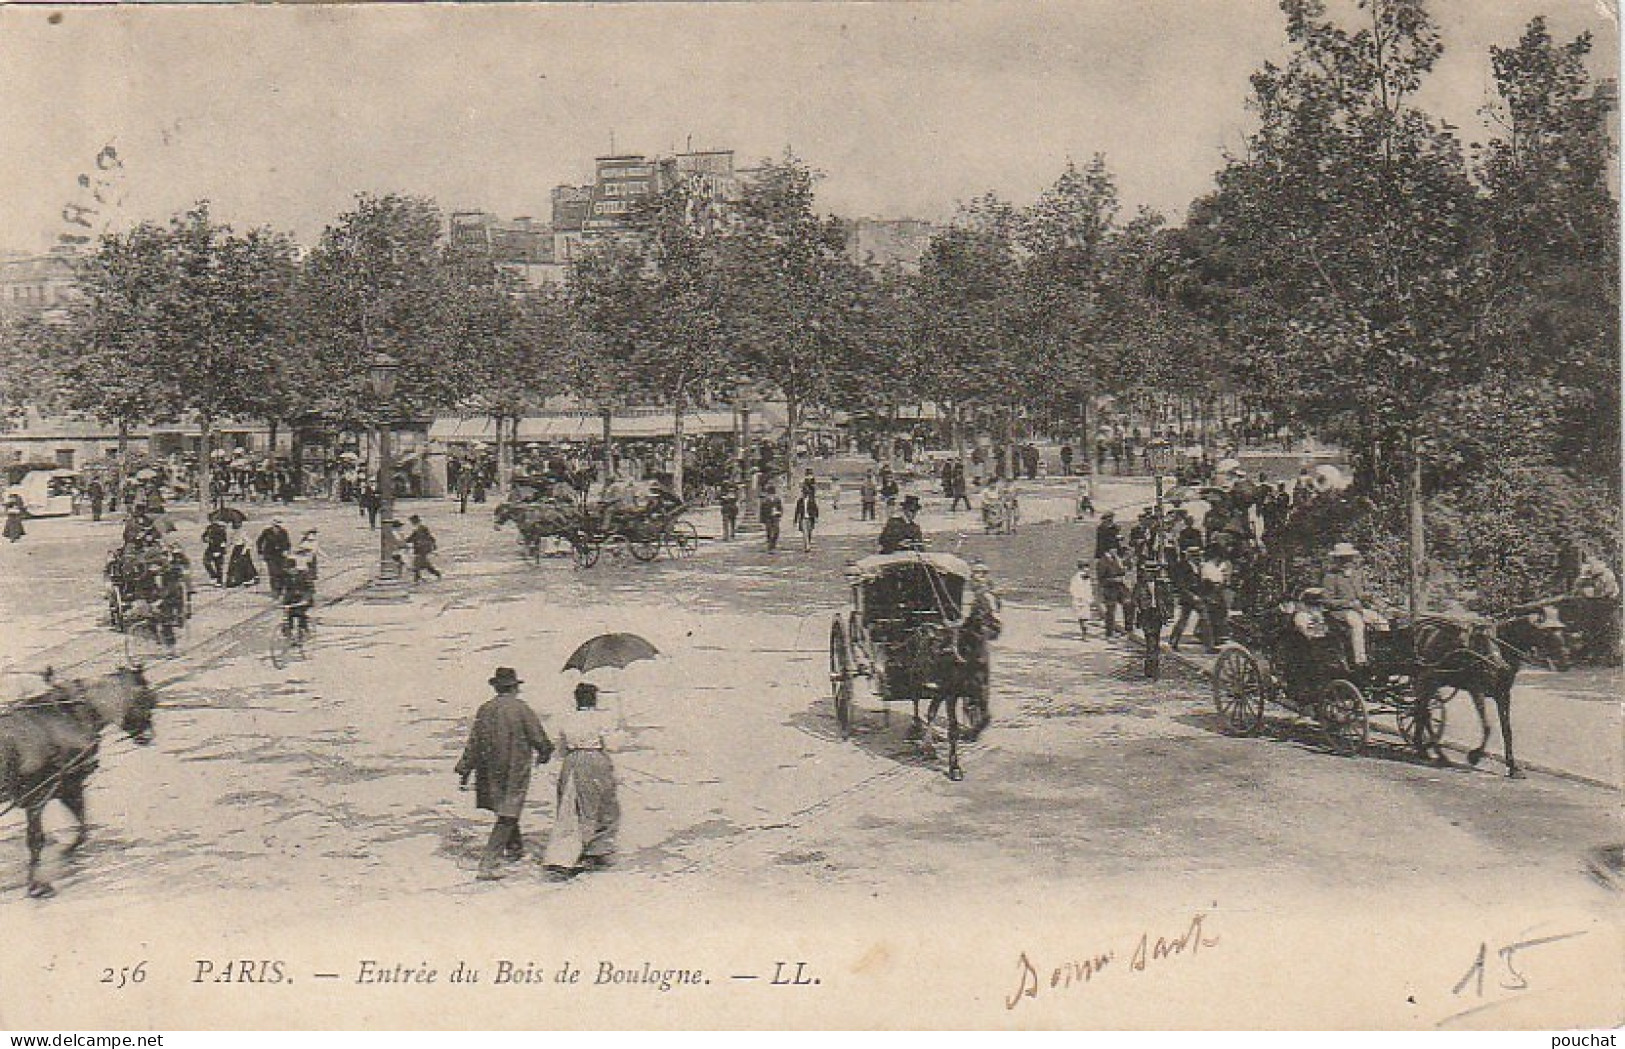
[0,666,158,900]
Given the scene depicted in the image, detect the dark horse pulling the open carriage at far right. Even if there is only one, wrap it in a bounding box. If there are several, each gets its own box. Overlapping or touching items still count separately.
[1393,612,1563,779]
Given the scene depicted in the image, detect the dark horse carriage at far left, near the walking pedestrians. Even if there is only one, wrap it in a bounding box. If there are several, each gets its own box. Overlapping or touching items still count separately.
[102,542,195,663]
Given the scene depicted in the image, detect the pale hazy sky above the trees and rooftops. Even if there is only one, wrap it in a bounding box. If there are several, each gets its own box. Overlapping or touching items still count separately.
[0,0,1619,250]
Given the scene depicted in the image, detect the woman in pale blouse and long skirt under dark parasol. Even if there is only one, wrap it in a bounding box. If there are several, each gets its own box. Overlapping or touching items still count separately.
[541,682,621,878]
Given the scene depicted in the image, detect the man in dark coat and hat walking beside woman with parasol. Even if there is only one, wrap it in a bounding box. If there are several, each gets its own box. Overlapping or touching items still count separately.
[457,666,553,882]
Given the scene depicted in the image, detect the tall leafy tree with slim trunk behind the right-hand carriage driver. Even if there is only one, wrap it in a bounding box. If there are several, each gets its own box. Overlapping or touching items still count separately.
[1199,0,1489,609]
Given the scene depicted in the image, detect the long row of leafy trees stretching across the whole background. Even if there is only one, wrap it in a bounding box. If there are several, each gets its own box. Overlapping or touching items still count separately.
[3,0,1620,601]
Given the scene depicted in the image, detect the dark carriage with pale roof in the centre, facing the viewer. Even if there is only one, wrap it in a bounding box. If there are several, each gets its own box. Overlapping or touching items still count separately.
[829,550,999,781]
